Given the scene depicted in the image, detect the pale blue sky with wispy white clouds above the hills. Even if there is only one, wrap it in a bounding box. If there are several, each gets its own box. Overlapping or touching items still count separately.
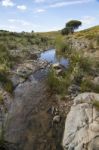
[0,0,99,32]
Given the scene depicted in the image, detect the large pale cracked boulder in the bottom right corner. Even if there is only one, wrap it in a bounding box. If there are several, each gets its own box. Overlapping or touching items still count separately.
[62,93,99,150]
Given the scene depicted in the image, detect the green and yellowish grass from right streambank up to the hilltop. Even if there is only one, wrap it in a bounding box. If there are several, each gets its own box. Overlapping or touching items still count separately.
[48,26,99,95]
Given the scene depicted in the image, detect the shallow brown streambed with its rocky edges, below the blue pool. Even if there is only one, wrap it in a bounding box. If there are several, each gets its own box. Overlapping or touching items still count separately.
[1,57,72,150]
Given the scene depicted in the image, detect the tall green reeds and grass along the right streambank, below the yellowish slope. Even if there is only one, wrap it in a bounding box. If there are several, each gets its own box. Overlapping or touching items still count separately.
[48,31,99,95]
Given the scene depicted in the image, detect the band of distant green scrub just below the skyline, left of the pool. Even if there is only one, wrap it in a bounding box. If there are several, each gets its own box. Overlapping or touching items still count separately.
[0,30,52,51]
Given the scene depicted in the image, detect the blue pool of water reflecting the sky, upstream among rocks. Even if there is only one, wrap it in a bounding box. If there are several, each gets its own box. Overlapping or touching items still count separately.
[40,49,68,67]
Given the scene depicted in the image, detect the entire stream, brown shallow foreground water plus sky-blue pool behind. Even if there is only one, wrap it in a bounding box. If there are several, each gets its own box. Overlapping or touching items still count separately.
[5,49,68,150]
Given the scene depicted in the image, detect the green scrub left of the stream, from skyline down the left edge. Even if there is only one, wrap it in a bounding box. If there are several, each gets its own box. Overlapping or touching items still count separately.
[0,30,53,93]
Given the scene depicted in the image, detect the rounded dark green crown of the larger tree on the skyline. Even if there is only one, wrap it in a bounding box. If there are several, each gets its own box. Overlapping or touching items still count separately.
[66,20,82,33]
